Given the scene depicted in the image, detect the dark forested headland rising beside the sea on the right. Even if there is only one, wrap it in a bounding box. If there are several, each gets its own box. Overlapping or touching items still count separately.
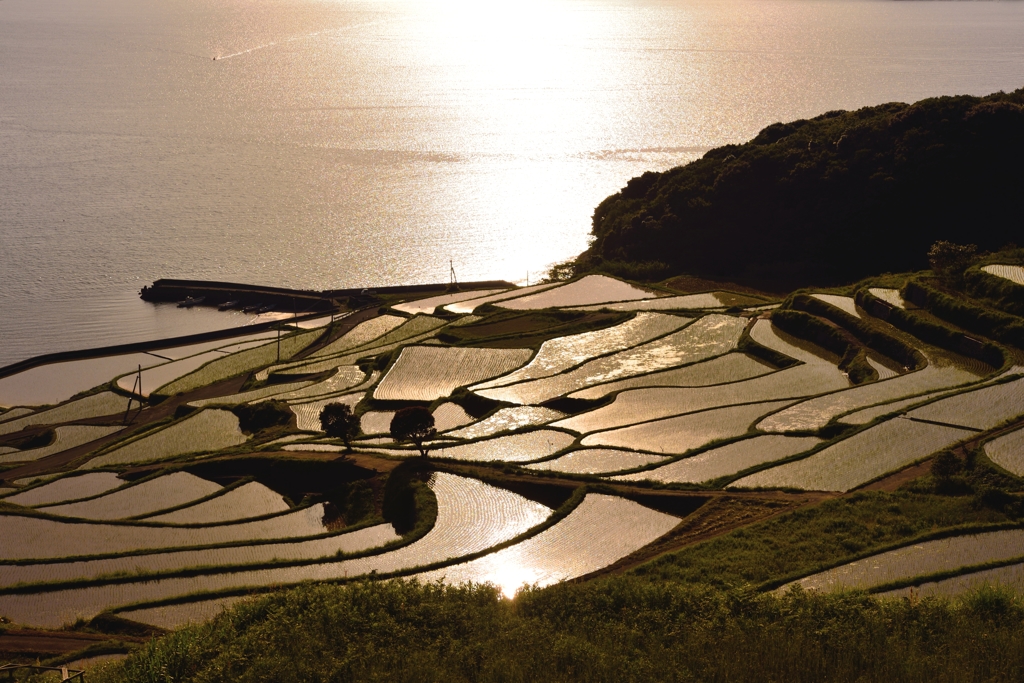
[575,89,1024,289]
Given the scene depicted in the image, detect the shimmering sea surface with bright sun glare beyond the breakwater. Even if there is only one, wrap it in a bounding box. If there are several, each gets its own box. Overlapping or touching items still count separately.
[0,0,1024,367]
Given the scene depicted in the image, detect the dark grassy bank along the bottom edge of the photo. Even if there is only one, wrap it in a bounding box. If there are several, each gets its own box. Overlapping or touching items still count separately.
[90,577,1024,683]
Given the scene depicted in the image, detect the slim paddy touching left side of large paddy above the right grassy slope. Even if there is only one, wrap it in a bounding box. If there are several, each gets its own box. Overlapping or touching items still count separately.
[613,435,821,483]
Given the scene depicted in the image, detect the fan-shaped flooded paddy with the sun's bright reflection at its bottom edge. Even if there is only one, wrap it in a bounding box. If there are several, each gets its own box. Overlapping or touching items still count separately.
[419,494,679,597]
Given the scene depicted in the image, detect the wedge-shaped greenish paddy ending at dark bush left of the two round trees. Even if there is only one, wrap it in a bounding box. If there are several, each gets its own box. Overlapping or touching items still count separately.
[83,409,248,469]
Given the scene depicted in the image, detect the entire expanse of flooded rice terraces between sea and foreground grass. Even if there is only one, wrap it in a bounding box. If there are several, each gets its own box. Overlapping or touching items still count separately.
[0,268,1024,627]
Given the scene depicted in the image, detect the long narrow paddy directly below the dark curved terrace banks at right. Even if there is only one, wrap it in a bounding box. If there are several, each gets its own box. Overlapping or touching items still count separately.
[758,365,978,432]
